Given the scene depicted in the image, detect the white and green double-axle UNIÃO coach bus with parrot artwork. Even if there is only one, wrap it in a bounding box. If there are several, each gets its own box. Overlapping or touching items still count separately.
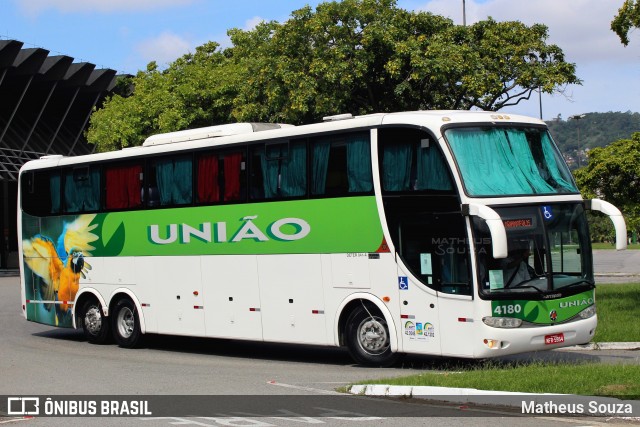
[18,111,626,365]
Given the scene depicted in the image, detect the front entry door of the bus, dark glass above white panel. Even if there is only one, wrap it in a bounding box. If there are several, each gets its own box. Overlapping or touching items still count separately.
[397,212,473,354]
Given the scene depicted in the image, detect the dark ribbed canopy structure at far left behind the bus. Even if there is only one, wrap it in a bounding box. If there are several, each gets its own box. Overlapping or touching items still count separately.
[0,40,116,181]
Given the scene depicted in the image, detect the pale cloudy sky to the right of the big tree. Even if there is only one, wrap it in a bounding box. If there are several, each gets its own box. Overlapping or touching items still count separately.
[410,0,640,119]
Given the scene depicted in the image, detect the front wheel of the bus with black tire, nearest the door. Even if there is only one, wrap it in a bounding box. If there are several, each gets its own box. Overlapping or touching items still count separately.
[345,305,398,367]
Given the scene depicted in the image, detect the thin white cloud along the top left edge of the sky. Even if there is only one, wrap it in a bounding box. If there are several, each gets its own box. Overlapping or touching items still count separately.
[15,0,194,17]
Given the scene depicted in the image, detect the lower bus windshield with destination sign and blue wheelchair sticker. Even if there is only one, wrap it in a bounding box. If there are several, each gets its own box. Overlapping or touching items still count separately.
[473,204,594,298]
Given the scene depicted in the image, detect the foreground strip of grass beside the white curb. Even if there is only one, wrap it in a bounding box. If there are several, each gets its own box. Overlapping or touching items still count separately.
[352,361,640,399]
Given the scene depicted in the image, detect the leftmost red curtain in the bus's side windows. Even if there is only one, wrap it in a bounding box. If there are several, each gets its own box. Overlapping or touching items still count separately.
[105,165,142,209]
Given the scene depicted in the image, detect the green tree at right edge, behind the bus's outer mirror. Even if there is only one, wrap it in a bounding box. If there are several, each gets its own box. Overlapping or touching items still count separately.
[575,132,640,237]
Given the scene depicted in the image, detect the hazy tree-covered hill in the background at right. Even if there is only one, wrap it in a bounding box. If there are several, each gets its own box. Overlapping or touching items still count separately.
[546,111,640,169]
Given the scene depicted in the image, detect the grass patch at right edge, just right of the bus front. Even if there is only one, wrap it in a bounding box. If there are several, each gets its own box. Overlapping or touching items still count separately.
[593,283,640,342]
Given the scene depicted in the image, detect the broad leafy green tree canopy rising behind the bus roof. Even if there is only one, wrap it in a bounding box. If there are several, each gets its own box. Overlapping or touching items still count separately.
[87,0,580,150]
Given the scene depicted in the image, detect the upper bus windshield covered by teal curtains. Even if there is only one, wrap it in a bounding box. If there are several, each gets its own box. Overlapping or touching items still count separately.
[444,126,578,197]
